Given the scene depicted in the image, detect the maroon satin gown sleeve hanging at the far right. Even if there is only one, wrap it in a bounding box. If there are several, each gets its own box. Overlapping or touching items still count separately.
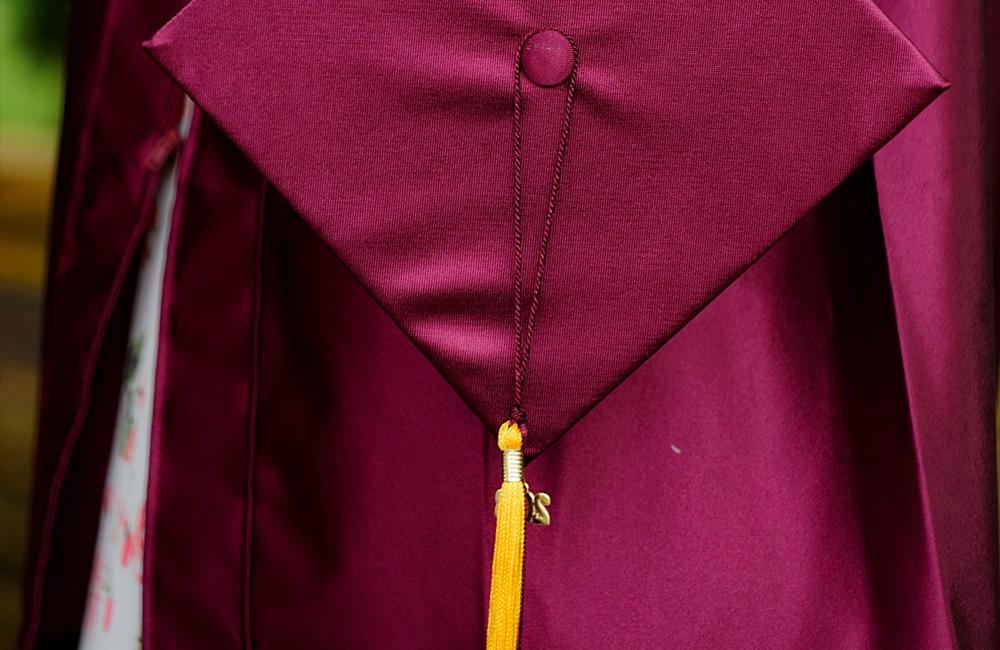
[875,0,1000,647]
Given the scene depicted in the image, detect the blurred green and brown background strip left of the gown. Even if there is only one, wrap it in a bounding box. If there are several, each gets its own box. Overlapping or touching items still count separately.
[0,0,68,648]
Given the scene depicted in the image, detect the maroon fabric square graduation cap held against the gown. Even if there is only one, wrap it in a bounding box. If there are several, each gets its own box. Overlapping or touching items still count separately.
[148,0,947,644]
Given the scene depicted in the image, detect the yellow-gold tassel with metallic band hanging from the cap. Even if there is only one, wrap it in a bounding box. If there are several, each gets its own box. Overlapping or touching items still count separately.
[486,421,527,650]
